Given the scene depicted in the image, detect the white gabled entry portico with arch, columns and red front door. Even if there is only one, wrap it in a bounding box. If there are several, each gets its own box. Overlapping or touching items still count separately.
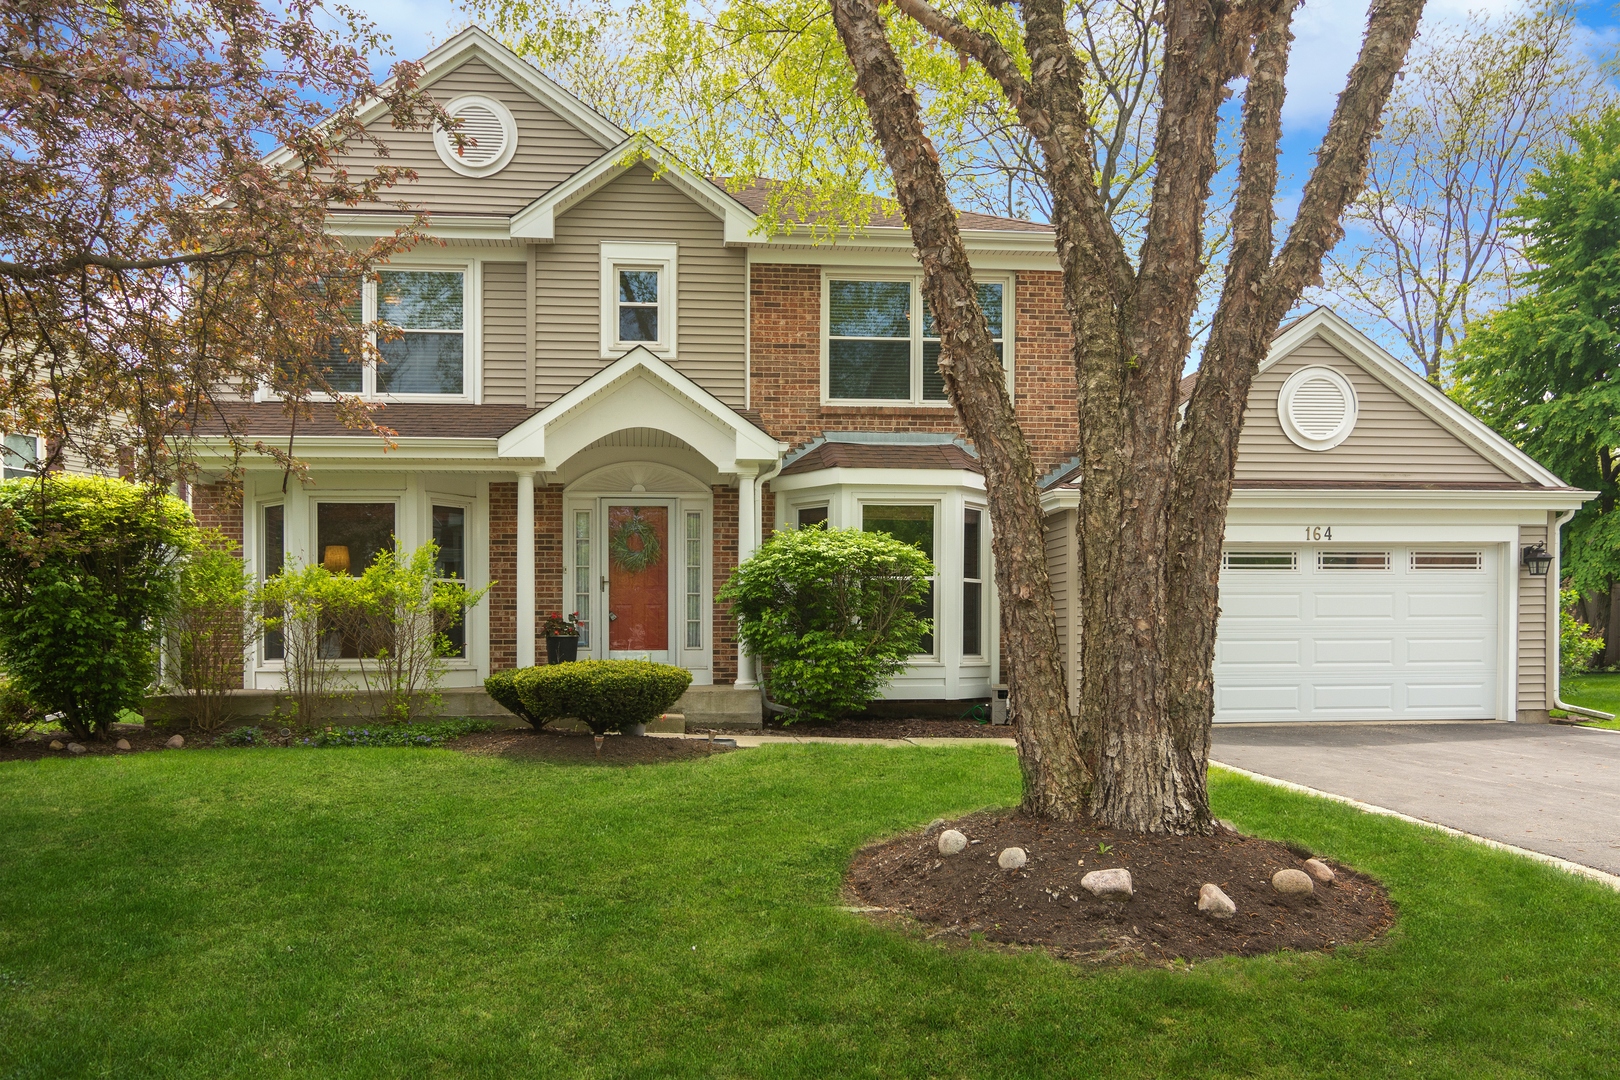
[497,348,787,687]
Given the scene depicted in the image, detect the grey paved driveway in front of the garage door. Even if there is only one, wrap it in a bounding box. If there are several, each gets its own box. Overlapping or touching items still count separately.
[1210,724,1620,874]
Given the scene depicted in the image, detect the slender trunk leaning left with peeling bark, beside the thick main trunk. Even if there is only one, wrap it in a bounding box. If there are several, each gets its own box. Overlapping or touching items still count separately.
[831,0,1092,819]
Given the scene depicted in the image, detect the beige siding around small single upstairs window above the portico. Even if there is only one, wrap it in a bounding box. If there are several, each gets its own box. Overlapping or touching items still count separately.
[535,165,747,408]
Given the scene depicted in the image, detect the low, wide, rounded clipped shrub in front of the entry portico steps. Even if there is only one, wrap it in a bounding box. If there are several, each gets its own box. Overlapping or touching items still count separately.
[514,661,692,735]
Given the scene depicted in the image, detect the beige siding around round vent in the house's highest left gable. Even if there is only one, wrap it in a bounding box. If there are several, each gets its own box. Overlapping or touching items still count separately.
[339,58,604,215]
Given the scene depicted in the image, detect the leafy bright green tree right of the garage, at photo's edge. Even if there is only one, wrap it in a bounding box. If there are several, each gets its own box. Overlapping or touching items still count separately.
[1455,107,1620,596]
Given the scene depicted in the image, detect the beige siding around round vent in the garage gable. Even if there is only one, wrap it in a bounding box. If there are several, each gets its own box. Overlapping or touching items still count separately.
[1236,337,1518,483]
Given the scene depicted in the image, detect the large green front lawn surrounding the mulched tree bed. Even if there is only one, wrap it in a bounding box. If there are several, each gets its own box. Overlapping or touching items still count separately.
[0,745,1620,1080]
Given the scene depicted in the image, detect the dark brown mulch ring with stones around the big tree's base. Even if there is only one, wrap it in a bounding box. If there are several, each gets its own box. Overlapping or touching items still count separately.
[846,811,1395,963]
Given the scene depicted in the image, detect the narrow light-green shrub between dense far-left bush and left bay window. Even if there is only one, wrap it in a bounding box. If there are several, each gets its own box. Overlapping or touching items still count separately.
[164,529,259,732]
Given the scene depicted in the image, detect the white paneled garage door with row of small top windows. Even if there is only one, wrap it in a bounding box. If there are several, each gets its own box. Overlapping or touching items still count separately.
[1215,546,1499,721]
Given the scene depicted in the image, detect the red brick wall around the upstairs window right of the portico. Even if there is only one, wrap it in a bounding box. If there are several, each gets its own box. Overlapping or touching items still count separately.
[748,264,1081,473]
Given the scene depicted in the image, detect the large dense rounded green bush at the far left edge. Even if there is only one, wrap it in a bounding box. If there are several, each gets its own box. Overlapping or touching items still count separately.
[0,474,196,738]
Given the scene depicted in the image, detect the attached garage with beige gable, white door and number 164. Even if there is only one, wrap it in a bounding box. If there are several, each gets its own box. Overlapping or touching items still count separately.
[1043,309,1591,722]
